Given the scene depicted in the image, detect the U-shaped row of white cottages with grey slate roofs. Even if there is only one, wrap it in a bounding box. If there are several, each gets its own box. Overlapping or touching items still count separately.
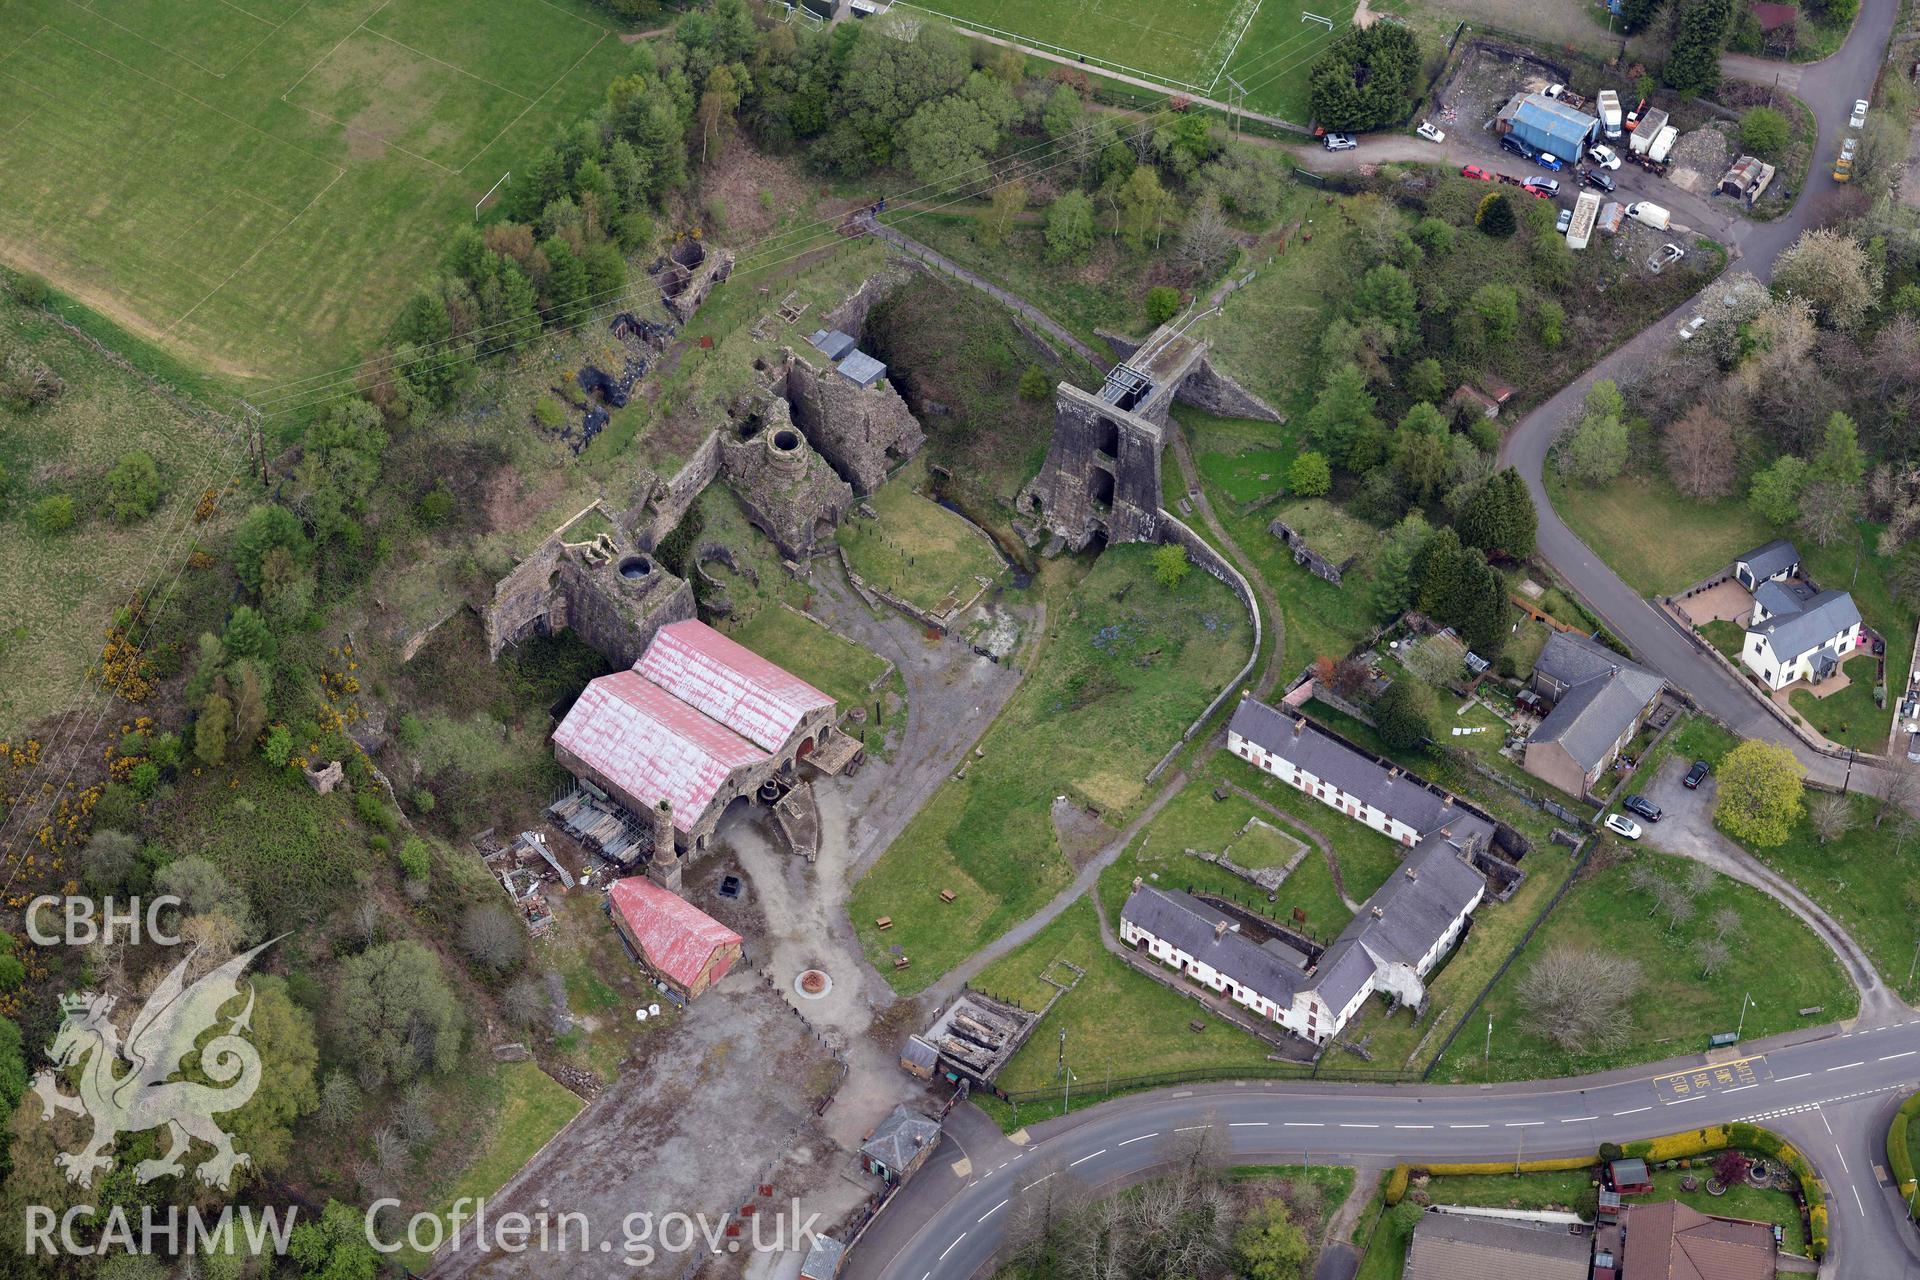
[1119,697,1494,1044]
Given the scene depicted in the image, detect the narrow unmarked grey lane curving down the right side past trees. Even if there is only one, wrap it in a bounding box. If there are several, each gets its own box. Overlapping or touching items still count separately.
[1500,0,1899,791]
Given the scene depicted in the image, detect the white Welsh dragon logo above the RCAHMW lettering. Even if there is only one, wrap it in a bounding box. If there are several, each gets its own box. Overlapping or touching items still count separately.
[33,938,278,1190]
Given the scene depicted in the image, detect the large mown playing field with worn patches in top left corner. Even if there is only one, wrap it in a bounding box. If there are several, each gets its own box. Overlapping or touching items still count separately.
[0,0,630,378]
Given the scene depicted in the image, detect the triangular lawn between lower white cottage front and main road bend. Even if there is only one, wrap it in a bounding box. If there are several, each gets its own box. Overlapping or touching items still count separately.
[972,896,1271,1123]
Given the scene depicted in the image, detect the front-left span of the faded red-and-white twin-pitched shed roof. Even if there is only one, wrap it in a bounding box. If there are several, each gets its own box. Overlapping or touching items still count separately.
[553,667,768,831]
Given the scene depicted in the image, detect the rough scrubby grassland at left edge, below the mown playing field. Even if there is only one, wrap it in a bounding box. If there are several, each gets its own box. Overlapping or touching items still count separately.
[0,289,246,743]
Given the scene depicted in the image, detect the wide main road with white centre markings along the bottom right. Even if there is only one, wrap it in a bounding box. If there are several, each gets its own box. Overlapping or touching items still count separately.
[871,1011,1920,1280]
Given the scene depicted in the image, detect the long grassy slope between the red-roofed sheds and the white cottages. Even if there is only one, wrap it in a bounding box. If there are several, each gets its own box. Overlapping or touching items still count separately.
[851,545,1252,992]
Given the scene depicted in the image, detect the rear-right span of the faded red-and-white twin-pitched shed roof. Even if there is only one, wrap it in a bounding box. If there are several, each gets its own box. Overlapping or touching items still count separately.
[634,622,833,752]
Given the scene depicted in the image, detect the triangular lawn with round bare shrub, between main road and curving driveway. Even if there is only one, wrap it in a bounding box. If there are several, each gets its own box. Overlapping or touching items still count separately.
[1440,837,1859,1080]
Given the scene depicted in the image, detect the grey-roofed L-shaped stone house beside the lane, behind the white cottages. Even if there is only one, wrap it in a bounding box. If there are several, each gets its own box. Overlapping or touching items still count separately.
[1523,631,1667,796]
